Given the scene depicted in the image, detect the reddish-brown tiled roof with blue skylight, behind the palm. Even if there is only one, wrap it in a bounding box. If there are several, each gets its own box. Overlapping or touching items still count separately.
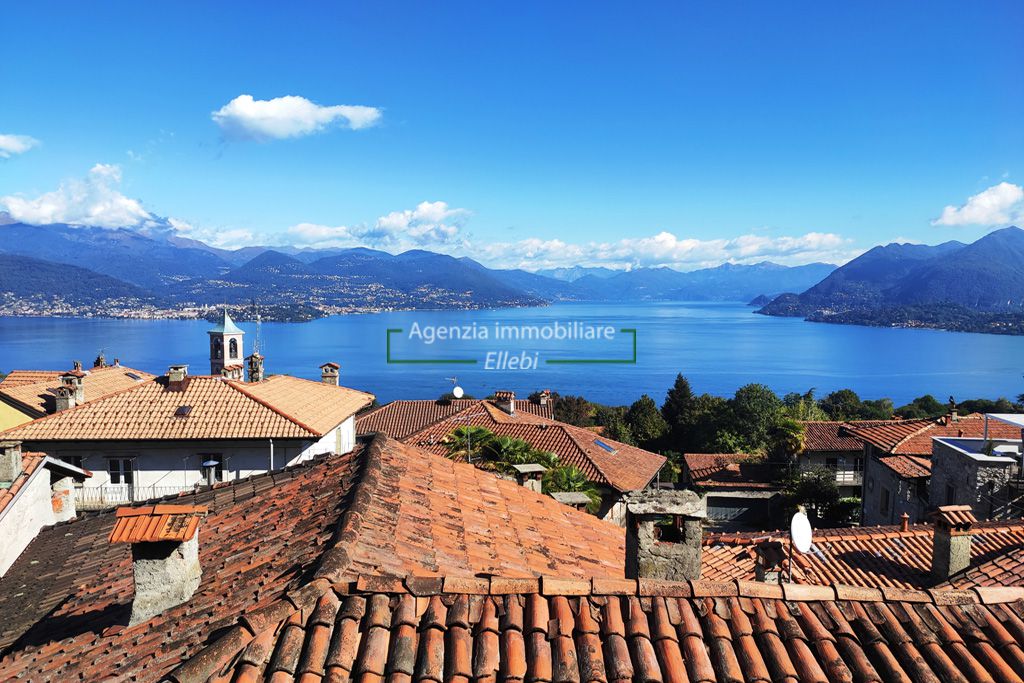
[402,400,667,492]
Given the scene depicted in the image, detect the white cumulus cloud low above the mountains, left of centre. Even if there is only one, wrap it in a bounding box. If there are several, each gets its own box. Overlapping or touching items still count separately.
[288,202,469,251]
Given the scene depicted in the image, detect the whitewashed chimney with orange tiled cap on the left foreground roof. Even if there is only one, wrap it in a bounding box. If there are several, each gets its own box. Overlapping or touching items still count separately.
[111,505,207,626]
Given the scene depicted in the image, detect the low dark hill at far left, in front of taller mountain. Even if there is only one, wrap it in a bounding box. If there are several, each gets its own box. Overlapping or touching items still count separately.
[0,254,153,306]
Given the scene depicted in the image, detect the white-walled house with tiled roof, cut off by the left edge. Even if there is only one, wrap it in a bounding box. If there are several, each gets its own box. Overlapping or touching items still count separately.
[0,441,91,577]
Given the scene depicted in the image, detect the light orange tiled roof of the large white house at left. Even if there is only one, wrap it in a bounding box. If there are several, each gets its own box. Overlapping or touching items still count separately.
[0,375,373,441]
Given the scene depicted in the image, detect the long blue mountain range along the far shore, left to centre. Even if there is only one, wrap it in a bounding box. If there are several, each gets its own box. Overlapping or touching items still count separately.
[0,216,835,314]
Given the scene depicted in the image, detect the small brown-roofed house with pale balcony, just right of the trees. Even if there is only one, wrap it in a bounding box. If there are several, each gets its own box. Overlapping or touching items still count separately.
[797,420,899,498]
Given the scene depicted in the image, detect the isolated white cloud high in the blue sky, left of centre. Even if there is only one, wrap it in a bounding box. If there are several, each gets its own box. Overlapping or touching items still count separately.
[210,95,381,140]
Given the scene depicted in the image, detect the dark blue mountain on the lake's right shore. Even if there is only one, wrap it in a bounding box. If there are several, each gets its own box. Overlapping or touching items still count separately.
[758,226,1024,332]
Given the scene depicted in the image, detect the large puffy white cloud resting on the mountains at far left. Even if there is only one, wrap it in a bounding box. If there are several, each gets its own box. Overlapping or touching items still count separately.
[0,164,154,227]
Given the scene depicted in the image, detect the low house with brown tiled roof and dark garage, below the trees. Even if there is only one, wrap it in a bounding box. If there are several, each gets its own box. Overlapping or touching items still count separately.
[679,453,781,529]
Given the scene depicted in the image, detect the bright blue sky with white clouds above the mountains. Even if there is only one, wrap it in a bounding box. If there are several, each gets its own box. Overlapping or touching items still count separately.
[0,1,1024,270]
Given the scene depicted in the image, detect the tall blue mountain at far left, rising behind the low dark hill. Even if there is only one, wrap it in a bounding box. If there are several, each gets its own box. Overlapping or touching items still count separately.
[0,222,230,289]
